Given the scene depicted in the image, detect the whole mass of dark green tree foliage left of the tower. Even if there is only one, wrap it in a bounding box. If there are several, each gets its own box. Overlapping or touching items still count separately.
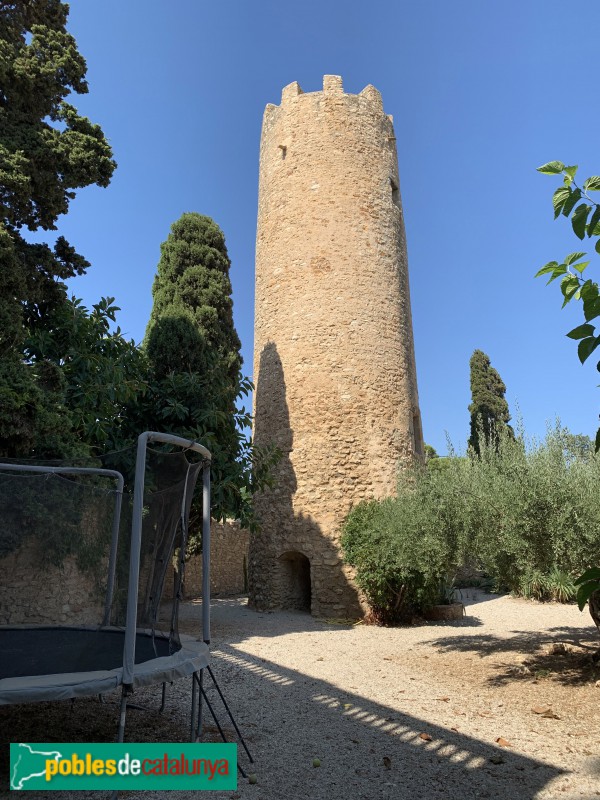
[0,6,275,523]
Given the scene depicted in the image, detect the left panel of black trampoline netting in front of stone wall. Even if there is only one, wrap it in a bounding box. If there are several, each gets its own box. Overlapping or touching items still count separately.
[0,469,119,625]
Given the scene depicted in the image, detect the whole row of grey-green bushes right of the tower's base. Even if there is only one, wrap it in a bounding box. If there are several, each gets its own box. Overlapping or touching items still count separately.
[342,424,600,624]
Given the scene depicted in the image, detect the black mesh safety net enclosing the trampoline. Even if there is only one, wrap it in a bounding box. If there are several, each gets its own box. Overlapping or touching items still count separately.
[0,440,205,680]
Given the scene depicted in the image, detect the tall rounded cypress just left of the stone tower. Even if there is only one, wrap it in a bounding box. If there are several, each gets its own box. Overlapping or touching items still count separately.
[140,213,248,518]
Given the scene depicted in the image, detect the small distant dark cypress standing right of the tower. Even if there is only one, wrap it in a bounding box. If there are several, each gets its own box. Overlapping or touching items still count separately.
[468,350,513,455]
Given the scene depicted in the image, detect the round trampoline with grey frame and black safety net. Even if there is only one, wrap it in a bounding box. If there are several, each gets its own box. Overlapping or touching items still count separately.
[0,432,212,741]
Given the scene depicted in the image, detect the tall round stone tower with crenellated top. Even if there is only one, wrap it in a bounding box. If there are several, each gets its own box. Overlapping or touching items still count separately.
[248,75,423,617]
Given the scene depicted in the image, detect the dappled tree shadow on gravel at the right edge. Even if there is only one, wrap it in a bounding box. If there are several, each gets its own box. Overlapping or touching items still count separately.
[423,626,600,686]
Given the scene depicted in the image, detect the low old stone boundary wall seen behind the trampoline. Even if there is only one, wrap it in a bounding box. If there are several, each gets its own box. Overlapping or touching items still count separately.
[0,521,250,625]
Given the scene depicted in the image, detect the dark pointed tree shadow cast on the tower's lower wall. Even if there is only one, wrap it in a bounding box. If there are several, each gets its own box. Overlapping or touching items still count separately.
[248,342,362,617]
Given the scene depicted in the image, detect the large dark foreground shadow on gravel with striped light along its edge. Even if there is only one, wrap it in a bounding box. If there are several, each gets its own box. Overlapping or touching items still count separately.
[205,644,563,800]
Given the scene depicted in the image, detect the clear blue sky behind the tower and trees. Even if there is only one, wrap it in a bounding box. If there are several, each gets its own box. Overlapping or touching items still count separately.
[50,0,600,453]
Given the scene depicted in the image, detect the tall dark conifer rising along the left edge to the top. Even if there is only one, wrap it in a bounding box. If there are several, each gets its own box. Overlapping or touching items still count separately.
[0,0,115,456]
